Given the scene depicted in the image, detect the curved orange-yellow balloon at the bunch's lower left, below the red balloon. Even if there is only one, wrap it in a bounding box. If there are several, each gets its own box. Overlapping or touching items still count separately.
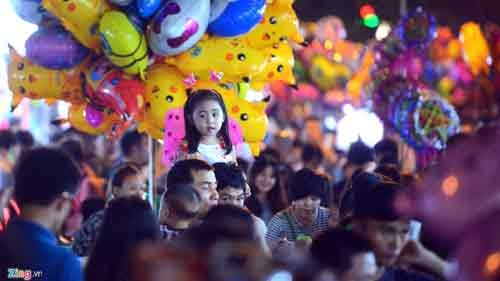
[68,104,121,135]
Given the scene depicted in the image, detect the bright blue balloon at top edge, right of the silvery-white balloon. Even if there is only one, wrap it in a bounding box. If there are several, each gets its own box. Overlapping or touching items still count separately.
[208,0,266,37]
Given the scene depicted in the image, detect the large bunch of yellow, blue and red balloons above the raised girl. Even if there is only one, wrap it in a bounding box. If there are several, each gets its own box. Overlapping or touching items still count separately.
[8,0,303,152]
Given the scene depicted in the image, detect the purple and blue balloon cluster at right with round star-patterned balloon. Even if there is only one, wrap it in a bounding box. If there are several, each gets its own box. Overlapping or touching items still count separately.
[372,8,460,155]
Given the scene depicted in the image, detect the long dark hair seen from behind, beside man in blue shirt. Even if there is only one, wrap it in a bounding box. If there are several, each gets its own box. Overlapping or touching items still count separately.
[85,197,160,281]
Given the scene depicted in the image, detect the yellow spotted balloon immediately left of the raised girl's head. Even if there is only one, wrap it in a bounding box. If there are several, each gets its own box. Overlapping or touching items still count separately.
[144,64,187,130]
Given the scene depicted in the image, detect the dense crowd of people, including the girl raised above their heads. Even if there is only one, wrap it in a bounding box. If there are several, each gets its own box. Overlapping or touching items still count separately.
[0,91,453,281]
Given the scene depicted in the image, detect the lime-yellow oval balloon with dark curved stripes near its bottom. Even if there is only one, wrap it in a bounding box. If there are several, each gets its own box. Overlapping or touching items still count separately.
[99,11,149,79]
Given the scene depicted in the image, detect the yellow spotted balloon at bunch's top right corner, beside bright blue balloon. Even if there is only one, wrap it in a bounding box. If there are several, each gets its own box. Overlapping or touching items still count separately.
[243,0,304,49]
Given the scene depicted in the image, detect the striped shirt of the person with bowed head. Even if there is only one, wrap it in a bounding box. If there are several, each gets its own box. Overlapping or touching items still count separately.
[266,207,330,245]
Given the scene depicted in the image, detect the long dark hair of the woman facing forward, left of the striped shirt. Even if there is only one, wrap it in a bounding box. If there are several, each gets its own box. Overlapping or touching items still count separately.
[246,156,288,217]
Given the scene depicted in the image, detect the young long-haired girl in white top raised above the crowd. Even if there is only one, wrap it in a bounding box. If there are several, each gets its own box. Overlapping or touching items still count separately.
[179,90,236,165]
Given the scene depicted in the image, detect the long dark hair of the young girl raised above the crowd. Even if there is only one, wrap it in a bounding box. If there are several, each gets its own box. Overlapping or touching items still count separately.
[184,89,233,154]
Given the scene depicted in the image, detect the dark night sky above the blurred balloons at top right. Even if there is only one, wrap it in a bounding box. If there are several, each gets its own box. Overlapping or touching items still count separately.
[294,0,500,41]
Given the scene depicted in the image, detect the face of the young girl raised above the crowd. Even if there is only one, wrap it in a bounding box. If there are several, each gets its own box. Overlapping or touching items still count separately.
[192,100,225,137]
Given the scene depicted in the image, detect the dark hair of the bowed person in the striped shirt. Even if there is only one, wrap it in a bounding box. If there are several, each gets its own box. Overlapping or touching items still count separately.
[290,168,327,201]
